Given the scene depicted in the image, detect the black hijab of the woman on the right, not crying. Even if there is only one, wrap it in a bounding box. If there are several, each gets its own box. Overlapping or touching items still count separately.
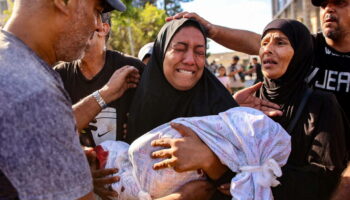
[260,19,313,129]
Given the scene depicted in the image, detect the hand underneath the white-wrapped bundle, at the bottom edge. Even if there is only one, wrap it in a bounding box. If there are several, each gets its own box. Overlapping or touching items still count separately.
[156,181,214,200]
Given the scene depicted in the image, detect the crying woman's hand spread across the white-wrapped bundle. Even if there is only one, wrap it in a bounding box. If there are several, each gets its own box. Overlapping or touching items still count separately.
[151,123,227,179]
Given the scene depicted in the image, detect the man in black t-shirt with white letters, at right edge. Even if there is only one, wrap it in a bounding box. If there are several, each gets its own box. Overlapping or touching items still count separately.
[307,0,350,122]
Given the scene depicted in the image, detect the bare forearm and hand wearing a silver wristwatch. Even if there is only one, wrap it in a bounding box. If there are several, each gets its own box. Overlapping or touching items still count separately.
[73,66,140,131]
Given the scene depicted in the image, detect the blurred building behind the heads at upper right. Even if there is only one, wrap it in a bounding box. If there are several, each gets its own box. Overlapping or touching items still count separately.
[272,0,321,33]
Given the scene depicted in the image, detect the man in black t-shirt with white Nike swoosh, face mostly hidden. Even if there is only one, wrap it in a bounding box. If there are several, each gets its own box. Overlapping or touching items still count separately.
[54,14,144,199]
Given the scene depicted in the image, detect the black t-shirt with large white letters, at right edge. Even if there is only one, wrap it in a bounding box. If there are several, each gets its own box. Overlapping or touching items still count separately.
[308,33,350,119]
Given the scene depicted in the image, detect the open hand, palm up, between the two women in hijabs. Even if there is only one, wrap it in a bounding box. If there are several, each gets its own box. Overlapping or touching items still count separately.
[233,82,283,117]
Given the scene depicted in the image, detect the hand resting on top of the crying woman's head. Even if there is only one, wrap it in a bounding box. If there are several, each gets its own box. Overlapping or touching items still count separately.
[166,12,217,38]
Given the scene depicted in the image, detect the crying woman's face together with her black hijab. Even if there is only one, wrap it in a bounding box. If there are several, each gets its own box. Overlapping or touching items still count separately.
[127,19,238,142]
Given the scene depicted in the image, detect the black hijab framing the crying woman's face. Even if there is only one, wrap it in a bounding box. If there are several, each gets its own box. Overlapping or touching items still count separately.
[126,19,238,143]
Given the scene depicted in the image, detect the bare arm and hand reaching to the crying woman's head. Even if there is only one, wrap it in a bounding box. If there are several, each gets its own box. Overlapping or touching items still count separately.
[167,12,260,55]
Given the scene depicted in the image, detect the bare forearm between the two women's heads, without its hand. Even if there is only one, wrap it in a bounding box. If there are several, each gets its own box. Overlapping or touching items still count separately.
[210,25,261,55]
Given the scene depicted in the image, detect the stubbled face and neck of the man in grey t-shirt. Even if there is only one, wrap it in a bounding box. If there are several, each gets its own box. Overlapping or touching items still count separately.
[4,0,103,64]
